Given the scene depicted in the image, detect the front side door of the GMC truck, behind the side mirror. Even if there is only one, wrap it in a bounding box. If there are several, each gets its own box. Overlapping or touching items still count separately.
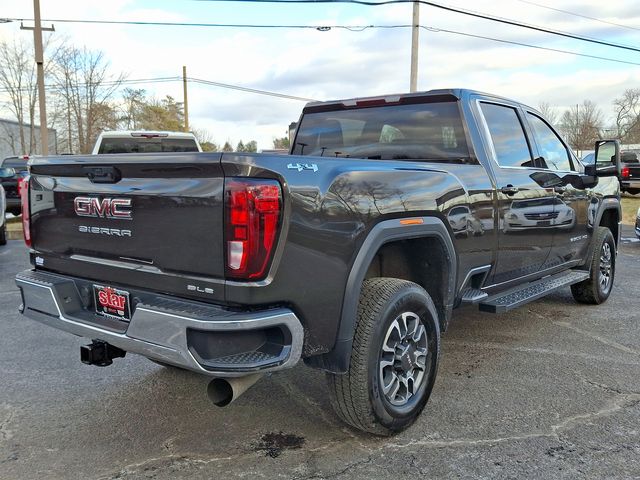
[526,111,591,266]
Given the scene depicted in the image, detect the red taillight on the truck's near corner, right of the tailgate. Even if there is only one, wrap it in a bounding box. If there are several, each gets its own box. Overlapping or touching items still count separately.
[225,178,282,280]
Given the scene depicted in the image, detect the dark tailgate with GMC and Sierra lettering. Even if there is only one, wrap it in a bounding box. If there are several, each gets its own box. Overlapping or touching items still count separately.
[30,153,224,293]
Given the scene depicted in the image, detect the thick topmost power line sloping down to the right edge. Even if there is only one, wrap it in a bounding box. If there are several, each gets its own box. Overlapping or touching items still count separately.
[197,0,640,52]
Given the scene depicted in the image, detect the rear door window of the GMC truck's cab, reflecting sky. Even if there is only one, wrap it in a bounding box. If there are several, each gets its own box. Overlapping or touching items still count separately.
[480,102,535,167]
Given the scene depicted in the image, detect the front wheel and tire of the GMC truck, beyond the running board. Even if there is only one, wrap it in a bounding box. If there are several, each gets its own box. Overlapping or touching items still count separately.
[571,227,616,305]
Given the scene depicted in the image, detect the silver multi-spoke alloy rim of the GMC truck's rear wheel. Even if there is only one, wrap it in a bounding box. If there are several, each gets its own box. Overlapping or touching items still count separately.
[379,312,428,407]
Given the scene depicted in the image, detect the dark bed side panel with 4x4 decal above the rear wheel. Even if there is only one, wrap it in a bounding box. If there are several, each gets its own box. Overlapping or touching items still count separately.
[222,154,495,355]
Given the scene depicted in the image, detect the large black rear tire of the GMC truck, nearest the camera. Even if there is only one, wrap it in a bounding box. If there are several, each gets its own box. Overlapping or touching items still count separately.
[327,278,440,435]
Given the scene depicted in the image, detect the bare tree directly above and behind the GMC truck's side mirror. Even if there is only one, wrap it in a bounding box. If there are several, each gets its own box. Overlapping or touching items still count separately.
[560,100,602,150]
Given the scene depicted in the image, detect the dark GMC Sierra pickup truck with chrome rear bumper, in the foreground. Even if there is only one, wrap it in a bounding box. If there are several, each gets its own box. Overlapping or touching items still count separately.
[16,90,621,435]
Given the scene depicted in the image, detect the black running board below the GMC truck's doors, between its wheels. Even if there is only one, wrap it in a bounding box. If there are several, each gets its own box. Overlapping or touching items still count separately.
[479,270,589,313]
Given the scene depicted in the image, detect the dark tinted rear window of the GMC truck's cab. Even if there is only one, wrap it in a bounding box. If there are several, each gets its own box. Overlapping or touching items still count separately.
[292,102,470,163]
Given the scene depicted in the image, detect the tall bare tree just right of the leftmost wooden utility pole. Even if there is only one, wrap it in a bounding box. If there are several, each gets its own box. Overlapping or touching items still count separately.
[53,47,124,153]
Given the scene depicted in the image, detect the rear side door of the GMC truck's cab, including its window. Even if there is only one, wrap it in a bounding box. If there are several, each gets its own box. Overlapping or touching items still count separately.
[477,100,555,284]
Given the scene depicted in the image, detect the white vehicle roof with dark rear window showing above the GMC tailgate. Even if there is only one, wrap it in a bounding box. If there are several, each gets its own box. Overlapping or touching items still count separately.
[91,130,202,155]
